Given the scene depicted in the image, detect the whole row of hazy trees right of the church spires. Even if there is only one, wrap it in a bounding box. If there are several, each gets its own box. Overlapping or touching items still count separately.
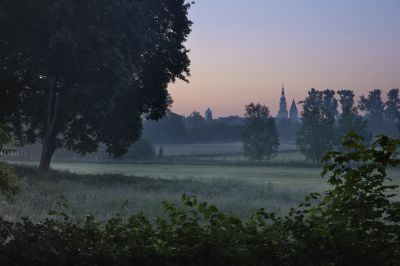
[297,89,400,161]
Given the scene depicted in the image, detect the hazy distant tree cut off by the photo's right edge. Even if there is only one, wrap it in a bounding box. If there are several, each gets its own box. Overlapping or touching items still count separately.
[385,89,400,136]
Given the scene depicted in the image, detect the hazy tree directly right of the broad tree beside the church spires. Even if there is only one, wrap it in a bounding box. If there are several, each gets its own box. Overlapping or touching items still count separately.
[337,90,371,143]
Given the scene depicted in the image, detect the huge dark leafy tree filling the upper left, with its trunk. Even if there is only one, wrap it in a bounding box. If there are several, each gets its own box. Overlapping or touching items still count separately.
[0,0,191,170]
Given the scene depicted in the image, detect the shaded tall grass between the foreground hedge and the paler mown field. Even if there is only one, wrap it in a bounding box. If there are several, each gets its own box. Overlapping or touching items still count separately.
[0,166,309,220]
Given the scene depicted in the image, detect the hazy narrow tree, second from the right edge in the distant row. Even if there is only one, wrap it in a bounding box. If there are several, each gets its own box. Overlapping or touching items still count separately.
[359,89,386,135]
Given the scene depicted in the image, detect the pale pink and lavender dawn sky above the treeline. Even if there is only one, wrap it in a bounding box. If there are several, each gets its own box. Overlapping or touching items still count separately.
[169,0,400,117]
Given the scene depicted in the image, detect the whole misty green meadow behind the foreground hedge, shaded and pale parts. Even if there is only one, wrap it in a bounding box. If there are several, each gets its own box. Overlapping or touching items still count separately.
[0,163,400,220]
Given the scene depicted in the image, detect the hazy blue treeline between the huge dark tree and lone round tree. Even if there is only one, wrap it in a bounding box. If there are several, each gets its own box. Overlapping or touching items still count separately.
[143,111,243,143]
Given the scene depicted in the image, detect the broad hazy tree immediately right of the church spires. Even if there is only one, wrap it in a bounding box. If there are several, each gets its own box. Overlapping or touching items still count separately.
[297,89,337,162]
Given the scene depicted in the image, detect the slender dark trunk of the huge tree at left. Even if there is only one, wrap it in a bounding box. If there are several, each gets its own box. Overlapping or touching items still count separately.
[39,84,59,172]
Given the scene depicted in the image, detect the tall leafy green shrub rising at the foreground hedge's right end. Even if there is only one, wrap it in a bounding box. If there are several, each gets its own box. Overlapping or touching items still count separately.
[289,132,400,265]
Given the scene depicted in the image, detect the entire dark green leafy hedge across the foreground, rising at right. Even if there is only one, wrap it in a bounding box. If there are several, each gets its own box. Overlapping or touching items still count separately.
[0,134,400,265]
